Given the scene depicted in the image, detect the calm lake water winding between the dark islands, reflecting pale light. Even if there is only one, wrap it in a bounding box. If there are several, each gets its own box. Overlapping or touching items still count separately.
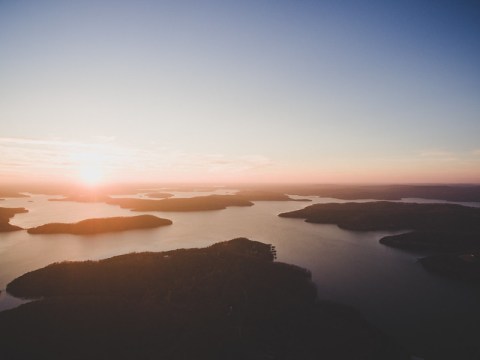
[0,194,480,359]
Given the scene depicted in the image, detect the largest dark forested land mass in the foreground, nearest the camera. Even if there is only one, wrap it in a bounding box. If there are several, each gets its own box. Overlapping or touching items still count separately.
[0,239,409,360]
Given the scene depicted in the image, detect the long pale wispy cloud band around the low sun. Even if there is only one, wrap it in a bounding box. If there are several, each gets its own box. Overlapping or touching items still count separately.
[0,137,273,180]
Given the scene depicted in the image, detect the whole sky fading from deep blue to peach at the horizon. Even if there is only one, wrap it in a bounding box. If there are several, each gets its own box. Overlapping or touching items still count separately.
[0,0,480,183]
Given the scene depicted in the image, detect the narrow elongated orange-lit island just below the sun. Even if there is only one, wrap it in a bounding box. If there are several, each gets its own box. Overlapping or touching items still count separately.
[27,215,172,235]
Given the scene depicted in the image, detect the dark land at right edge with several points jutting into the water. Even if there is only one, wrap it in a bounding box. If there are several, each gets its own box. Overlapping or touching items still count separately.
[279,201,480,283]
